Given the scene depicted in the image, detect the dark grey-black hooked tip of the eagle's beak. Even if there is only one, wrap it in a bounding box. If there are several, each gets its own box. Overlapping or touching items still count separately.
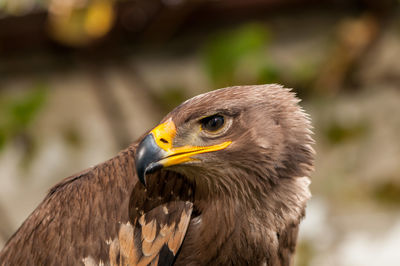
[135,134,165,186]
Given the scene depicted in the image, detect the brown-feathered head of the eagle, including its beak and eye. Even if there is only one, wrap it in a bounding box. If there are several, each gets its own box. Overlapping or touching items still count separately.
[135,85,313,197]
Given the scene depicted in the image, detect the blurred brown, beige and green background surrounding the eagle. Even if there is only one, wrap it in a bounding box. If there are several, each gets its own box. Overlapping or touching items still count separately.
[0,0,400,266]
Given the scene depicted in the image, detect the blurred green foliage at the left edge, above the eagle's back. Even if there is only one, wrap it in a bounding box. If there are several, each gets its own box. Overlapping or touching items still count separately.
[0,84,47,150]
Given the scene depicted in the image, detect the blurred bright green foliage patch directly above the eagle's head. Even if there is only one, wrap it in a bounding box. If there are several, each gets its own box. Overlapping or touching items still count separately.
[204,24,272,86]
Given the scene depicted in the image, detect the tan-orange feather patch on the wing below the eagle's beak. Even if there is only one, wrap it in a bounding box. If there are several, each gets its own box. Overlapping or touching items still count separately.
[98,202,192,266]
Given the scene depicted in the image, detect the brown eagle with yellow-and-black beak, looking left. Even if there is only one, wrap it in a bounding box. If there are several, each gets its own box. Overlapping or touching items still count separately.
[0,84,314,266]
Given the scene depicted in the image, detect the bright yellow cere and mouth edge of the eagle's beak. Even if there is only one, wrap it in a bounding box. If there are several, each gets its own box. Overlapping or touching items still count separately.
[150,119,232,167]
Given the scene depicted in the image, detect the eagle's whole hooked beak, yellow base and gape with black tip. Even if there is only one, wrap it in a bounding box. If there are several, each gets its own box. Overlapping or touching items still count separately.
[135,118,232,185]
